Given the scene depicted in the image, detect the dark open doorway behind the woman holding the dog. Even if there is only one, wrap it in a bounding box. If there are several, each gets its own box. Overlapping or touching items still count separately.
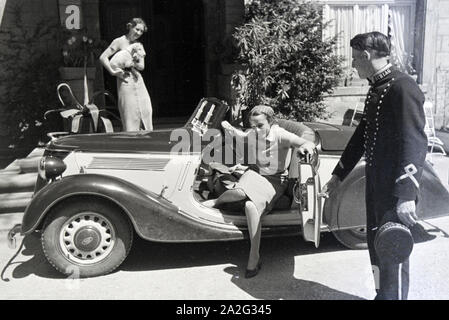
[100,0,205,117]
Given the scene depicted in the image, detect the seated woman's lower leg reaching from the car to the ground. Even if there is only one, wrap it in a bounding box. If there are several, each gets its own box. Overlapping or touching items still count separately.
[245,201,262,270]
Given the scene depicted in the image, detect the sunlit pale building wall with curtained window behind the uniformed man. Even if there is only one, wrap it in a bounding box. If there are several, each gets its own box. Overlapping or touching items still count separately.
[322,0,449,128]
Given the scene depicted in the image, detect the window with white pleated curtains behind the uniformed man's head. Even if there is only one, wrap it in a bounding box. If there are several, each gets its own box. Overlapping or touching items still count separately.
[323,0,416,84]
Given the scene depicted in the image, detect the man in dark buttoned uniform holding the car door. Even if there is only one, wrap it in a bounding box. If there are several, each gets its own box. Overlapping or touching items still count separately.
[322,32,427,300]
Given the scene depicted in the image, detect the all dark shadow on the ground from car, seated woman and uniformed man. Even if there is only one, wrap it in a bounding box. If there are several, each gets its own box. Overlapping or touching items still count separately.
[3,226,440,300]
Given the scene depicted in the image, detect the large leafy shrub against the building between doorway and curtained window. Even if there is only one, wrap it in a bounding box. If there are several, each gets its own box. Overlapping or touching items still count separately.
[231,0,342,121]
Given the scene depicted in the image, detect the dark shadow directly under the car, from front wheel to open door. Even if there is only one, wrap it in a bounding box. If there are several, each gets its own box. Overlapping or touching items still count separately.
[121,234,347,271]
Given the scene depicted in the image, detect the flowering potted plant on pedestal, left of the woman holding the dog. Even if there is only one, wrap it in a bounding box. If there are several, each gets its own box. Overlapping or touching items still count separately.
[59,30,105,103]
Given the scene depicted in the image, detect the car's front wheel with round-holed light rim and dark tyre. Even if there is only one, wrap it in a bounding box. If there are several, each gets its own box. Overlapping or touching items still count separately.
[41,197,133,278]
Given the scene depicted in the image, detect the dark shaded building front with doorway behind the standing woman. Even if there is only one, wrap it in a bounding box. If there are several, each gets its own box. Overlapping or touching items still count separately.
[0,0,244,131]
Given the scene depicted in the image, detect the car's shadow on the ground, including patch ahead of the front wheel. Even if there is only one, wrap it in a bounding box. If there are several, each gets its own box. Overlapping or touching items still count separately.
[3,234,346,279]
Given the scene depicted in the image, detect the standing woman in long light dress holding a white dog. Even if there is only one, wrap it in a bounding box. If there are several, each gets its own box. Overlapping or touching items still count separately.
[100,18,153,131]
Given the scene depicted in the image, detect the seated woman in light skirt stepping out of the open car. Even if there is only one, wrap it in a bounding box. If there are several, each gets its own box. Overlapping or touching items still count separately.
[203,105,315,278]
